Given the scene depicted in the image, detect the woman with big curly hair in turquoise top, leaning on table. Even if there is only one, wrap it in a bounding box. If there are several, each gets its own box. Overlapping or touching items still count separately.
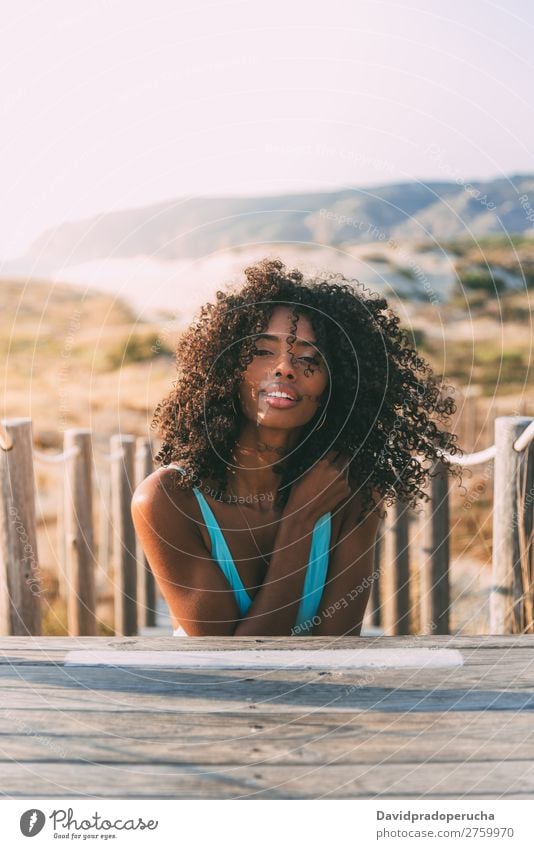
[132,259,458,636]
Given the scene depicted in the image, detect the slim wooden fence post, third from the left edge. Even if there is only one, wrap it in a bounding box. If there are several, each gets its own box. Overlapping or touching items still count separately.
[110,433,137,637]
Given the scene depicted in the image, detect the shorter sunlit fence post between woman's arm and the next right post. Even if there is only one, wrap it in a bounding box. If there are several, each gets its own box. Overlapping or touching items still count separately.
[381,501,411,636]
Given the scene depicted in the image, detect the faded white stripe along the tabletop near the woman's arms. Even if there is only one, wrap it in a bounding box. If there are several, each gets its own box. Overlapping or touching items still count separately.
[64,648,464,669]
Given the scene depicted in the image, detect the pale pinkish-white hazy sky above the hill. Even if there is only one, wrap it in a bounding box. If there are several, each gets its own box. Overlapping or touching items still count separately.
[0,0,534,258]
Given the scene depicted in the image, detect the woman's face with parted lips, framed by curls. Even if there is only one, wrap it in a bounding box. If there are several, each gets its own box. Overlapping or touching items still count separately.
[239,306,328,429]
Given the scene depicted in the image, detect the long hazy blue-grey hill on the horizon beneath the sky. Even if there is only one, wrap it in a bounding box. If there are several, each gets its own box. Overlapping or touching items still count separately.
[3,175,534,275]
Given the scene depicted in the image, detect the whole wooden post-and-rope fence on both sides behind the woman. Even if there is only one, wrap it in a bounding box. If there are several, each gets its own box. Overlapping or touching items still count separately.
[0,416,534,636]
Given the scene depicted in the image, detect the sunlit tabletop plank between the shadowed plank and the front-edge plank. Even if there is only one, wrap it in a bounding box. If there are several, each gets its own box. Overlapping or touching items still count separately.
[0,712,534,765]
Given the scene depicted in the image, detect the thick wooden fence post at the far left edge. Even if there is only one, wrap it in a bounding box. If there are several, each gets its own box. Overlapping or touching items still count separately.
[0,418,41,637]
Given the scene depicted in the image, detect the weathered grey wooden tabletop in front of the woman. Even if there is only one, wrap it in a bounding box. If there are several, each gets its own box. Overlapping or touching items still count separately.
[0,635,534,799]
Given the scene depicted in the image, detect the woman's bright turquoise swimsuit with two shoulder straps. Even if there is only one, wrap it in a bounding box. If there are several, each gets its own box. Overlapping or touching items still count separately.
[169,463,332,637]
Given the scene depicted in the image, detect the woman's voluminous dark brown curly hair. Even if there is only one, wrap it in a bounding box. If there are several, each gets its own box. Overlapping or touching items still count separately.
[151,258,461,518]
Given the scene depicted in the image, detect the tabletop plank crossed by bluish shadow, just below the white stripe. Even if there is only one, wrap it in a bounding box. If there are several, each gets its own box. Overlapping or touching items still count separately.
[2,667,534,714]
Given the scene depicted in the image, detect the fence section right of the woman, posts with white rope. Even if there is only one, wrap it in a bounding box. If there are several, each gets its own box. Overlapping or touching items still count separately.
[371,416,534,634]
